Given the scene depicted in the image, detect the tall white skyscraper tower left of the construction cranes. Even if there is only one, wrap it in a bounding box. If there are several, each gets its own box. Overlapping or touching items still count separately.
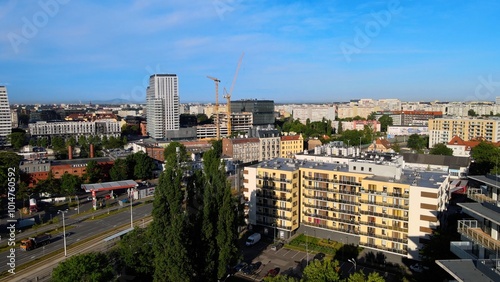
[146,74,180,139]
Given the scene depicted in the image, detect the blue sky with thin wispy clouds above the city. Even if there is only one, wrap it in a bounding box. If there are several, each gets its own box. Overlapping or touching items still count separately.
[0,0,500,103]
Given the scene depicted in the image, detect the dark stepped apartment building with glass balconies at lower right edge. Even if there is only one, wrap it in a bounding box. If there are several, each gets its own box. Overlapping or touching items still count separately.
[436,175,500,281]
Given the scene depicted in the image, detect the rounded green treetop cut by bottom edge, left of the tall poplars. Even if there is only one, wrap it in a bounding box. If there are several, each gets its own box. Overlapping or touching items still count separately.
[51,253,115,282]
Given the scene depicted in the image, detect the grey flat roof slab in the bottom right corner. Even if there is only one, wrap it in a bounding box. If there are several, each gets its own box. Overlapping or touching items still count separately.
[436,259,498,282]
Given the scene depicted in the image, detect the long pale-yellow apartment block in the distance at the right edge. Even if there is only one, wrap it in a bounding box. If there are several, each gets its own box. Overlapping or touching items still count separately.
[429,118,500,148]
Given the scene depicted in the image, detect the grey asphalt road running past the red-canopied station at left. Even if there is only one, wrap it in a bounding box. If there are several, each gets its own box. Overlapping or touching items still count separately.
[0,203,152,272]
